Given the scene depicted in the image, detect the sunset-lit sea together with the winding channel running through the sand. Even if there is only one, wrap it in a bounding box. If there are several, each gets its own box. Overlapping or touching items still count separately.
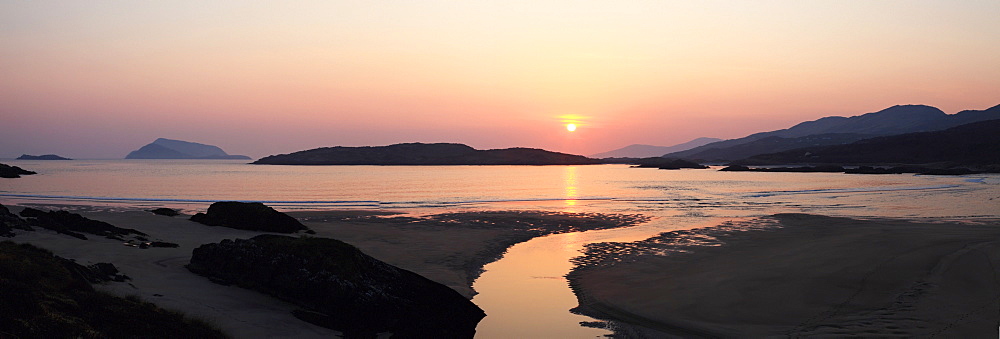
[0,160,1000,338]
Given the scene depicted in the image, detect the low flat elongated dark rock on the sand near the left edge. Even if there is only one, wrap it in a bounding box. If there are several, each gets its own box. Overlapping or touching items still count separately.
[21,207,147,240]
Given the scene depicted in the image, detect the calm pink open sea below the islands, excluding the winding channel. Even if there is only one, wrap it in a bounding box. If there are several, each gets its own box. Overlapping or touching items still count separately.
[0,160,1000,217]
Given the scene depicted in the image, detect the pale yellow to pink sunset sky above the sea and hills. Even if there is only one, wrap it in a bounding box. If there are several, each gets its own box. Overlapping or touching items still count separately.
[0,0,1000,158]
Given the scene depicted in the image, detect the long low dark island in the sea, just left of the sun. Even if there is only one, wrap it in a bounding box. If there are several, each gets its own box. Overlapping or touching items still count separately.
[253,143,602,165]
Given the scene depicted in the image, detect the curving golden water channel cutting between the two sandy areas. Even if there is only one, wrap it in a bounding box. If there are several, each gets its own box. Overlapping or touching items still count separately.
[472,218,718,338]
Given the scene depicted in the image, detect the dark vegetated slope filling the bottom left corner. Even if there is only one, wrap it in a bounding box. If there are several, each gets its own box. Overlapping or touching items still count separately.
[0,241,225,338]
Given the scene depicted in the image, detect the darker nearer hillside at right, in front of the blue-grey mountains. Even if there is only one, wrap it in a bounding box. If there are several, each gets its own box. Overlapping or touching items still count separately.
[738,120,1000,168]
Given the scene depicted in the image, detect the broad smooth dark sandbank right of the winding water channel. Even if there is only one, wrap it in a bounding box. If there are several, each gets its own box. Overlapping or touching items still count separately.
[569,214,1000,337]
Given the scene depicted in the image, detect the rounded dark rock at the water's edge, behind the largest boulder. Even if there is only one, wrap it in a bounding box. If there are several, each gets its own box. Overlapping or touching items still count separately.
[191,201,308,233]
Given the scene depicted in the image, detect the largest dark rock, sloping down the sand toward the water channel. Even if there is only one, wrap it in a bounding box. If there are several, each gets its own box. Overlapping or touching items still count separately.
[187,235,485,338]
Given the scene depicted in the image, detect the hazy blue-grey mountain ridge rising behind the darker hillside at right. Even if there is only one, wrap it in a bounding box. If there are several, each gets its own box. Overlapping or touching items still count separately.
[664,105,1000,161]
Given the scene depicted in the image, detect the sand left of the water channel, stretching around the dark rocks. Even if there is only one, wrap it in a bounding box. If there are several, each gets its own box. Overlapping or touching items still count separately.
[0,205,646,338]
